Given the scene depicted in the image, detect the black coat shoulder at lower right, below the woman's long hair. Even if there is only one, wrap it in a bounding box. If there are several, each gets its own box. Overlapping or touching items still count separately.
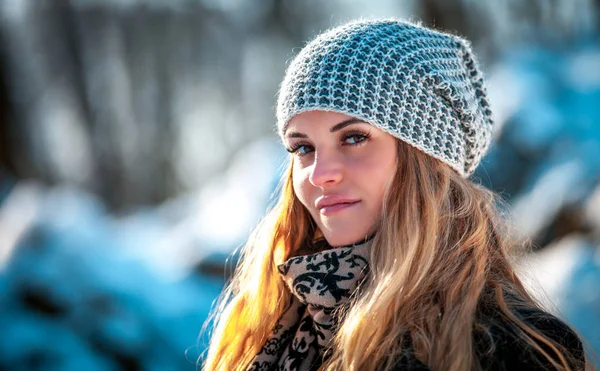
[473,308,585,370]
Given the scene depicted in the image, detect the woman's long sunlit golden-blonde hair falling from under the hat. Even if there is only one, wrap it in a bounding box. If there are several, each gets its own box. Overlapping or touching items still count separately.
[204,142,576,371]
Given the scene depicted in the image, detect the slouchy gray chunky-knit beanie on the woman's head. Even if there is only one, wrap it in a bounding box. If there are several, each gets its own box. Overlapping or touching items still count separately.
[277,20,493,177]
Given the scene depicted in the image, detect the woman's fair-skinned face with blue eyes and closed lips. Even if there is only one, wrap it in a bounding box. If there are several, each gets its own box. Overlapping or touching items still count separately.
[284,111,398,250]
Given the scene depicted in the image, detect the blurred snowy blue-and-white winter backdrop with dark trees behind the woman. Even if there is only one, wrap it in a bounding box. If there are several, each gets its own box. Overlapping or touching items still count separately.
[0,0,600,371]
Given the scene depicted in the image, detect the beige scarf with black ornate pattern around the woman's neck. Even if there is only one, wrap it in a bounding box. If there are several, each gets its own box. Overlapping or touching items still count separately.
[248,239,371,371]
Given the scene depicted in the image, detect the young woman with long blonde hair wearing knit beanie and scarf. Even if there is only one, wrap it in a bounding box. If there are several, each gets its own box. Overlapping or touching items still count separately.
[204,20,585,370]
